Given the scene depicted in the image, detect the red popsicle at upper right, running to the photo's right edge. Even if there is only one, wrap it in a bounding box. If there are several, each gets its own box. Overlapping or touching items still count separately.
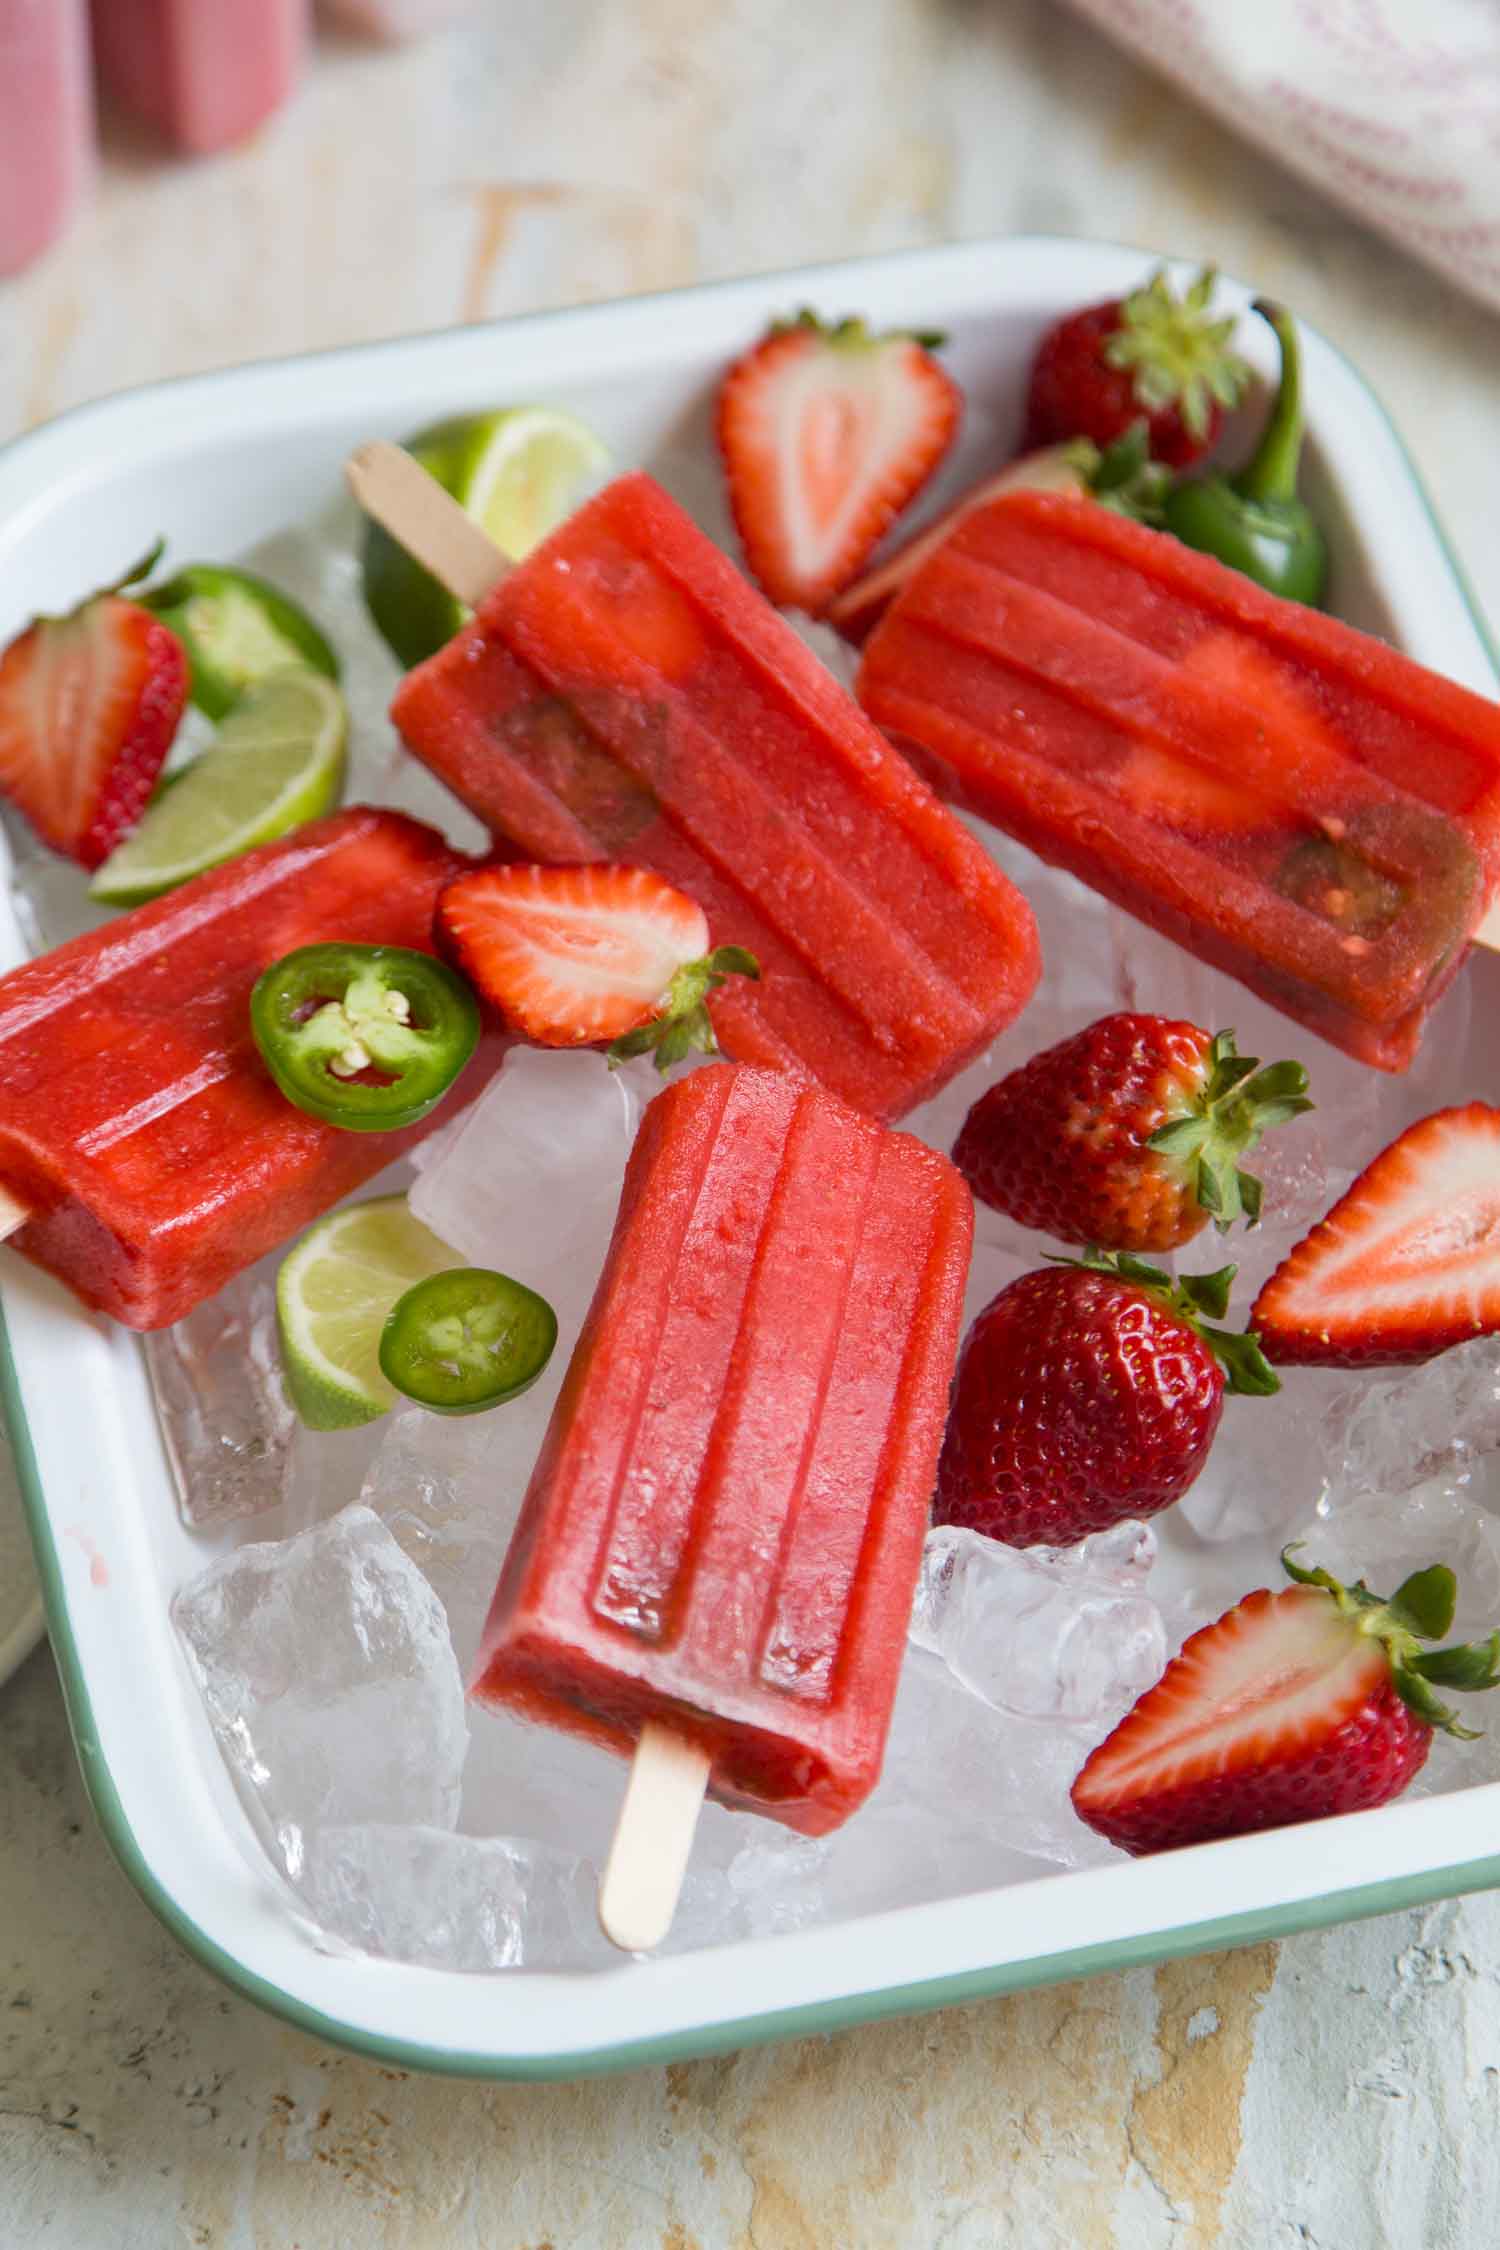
[857,493,1500,1071]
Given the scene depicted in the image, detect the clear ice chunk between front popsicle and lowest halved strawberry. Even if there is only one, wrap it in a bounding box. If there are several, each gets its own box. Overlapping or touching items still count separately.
[911,1523,1167,1719]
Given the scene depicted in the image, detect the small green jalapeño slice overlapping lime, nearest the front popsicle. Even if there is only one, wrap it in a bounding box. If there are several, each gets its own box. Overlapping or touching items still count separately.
[380,1267,558,1413]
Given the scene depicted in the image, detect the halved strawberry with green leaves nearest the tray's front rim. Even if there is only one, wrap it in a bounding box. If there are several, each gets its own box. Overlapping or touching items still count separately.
[1073,1548,1500,1852]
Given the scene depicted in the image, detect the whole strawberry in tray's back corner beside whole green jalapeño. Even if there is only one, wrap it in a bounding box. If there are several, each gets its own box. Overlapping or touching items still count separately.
[1021,266,1250,468]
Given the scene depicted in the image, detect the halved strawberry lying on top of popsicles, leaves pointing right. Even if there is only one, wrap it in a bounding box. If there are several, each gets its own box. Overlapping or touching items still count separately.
[436,862,760,1071]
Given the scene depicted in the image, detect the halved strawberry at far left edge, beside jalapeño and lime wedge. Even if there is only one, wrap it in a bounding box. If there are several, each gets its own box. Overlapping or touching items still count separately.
[0,547,187,866]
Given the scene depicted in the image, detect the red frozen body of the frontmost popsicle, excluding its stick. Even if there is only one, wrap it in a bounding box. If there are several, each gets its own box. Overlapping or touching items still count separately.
[472,1064,974,1863]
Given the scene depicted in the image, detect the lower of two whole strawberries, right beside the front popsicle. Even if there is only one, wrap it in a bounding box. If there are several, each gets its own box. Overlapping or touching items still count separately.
[933,1256,1280,1546]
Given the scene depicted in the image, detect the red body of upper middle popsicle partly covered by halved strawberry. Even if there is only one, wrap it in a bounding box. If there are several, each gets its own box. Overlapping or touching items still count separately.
[384,468,1039,1116]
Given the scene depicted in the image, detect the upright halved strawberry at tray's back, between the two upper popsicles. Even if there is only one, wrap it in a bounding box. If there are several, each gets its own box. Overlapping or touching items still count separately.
[717,313,963,617]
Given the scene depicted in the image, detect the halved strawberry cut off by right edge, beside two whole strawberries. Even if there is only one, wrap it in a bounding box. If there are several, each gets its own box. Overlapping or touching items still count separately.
[1250,1103,1500,1368]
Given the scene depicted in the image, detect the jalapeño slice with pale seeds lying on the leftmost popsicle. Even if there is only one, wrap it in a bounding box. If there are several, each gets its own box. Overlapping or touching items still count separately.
[250,941,479,1132]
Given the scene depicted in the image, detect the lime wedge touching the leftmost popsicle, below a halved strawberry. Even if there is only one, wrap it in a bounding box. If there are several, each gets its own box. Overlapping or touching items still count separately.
[90,671,346,907]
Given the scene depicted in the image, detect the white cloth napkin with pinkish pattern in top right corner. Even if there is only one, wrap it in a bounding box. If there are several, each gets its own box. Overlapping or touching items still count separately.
[1073,0,1500,306]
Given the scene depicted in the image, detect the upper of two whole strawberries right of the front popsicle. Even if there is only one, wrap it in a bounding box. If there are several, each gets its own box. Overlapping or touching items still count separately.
[954,1015,1313,1251]
